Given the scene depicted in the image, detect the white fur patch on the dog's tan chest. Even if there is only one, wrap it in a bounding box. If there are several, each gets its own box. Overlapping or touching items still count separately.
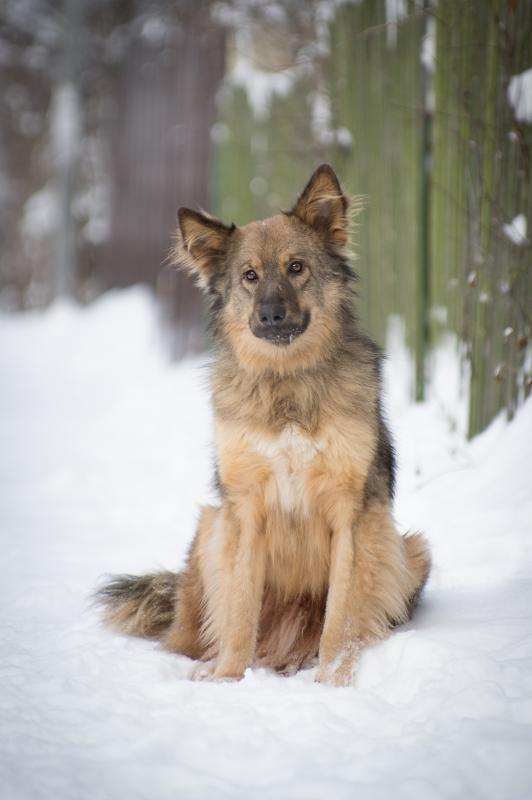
[248,425,323,514]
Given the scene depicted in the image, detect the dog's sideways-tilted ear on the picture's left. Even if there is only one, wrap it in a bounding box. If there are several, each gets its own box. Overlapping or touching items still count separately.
[172,208,236,289]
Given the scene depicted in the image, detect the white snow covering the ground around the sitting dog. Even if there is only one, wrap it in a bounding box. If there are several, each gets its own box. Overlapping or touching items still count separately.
[0,289,532,800]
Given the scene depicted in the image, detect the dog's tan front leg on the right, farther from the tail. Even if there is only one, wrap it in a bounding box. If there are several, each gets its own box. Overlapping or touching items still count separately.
[316,511,359,686]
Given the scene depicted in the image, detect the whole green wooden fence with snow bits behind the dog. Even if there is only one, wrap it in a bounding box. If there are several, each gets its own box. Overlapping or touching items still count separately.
[213,0,532,435]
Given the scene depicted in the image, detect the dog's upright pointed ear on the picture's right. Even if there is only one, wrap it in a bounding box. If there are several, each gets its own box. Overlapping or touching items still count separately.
[289,164,349,248]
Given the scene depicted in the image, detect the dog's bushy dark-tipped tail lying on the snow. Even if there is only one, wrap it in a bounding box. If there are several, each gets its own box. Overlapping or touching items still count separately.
[94,572,179,639]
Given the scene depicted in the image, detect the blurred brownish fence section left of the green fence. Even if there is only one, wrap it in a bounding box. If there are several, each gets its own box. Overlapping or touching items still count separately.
[104,2,225,356]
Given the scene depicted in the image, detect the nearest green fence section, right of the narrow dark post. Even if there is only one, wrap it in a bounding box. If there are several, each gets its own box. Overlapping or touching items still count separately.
[430,0,532,435]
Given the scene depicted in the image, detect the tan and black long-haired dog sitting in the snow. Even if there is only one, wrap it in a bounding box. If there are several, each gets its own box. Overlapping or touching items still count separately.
[98,164,430,686]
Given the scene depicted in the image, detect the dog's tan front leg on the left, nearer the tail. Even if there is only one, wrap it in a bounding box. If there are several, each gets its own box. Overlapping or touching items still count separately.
[213,498,266,680]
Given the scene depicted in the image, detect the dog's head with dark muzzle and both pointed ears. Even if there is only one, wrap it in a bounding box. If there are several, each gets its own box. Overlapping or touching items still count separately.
[175,164,353,370]
